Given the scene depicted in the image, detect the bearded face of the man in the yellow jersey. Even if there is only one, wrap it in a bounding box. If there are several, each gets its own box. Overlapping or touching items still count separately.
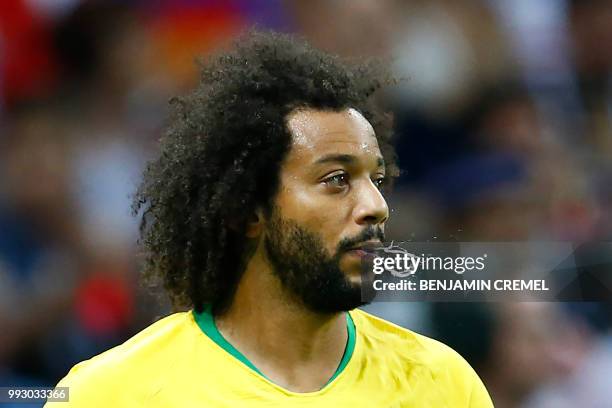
[264,109,389,312]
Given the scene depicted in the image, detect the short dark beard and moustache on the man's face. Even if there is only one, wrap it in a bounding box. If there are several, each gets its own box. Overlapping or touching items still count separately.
[264,208,383,313]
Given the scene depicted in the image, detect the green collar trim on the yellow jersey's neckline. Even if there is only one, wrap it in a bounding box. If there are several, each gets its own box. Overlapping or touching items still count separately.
[193,305,357,386]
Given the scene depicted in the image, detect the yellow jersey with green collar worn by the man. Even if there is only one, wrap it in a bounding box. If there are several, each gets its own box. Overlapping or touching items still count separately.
[46,310,493,408]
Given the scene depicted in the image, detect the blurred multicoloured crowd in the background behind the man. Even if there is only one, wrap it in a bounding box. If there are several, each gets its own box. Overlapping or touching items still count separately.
[0,0,612,408]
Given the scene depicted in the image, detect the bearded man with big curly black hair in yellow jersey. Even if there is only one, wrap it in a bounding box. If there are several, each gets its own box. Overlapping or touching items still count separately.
[49,33,492,408]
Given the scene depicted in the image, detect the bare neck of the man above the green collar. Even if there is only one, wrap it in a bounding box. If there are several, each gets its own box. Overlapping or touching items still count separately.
[215,255,348,392]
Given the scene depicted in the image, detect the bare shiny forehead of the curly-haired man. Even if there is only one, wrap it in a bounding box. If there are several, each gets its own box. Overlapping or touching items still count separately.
[287,108,378,151]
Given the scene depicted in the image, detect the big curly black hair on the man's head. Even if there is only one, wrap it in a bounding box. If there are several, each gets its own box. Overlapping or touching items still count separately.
[133,31,398,311]
